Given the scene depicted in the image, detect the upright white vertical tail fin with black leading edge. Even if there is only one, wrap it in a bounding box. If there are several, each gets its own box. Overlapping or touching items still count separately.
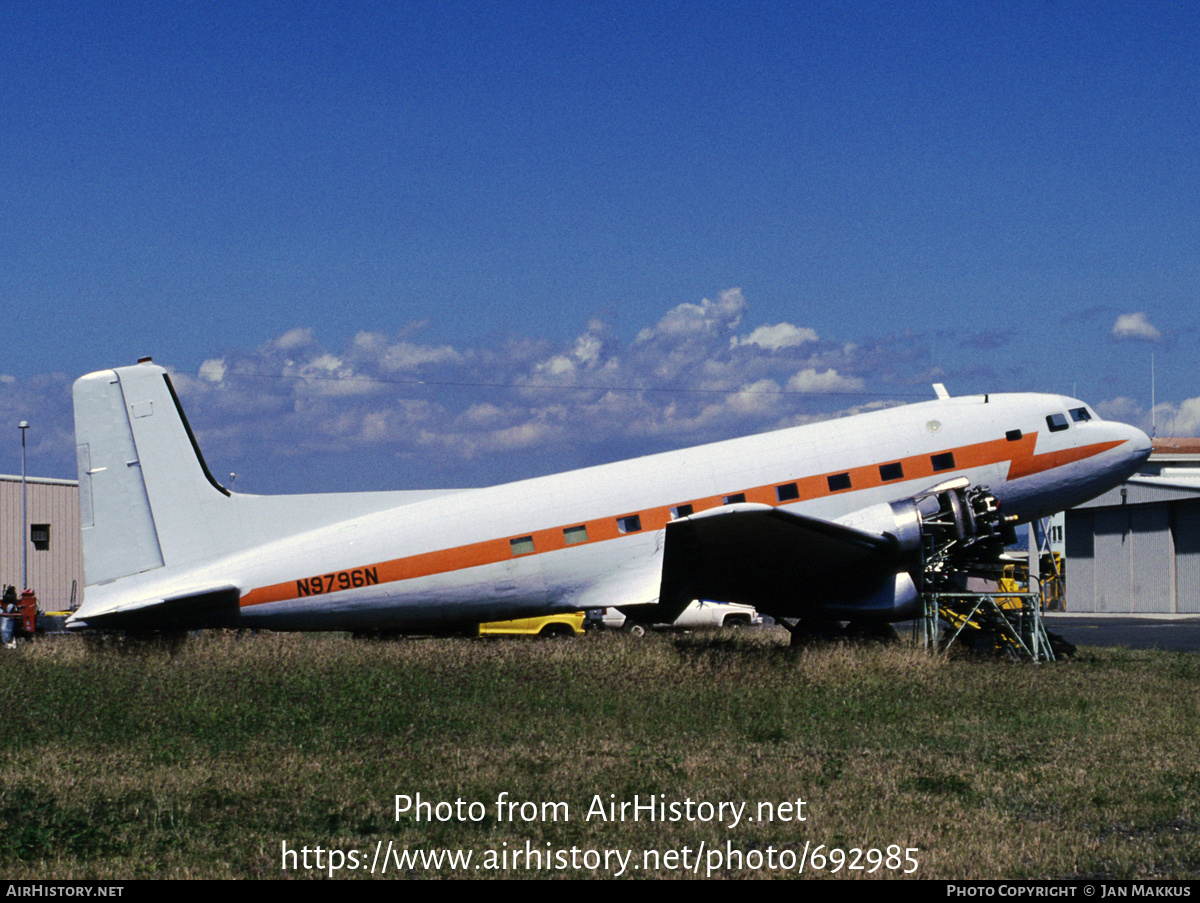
[74,363,229,586]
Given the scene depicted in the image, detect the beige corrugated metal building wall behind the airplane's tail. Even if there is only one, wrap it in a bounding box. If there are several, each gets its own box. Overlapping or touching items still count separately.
[0,477,83,611]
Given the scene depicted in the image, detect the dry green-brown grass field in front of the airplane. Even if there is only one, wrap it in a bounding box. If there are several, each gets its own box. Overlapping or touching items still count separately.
[0,629,1200,879]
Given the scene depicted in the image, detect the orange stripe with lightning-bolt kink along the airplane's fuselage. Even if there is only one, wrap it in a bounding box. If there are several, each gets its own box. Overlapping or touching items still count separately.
[241,432,1121,606]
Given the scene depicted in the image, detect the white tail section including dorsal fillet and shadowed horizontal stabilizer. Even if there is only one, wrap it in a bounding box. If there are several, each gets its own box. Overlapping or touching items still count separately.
[67,361,440,629]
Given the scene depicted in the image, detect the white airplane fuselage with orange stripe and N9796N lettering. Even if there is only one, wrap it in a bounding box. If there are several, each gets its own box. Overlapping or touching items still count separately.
[68,362,1150,629]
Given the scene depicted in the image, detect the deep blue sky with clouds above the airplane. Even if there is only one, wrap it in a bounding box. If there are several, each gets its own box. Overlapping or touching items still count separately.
[0,0,1200,491]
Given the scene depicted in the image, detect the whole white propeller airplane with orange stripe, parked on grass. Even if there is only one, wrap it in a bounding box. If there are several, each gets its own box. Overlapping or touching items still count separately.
[68,360,1150,632]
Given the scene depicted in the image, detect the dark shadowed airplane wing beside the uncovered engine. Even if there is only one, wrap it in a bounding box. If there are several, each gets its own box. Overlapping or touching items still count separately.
[659,503,911,620]
